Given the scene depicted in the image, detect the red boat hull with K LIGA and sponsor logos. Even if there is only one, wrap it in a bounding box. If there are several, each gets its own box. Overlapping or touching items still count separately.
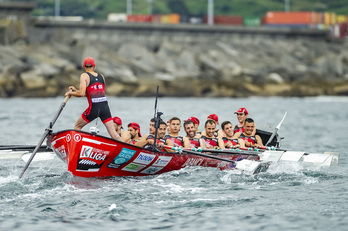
[48,130,260,177]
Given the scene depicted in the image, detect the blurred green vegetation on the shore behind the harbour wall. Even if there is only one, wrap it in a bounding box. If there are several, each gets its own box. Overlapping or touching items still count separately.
[11,0,348,19]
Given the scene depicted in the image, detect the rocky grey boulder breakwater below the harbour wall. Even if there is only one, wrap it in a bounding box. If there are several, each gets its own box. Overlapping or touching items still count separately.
[0,34,348,97]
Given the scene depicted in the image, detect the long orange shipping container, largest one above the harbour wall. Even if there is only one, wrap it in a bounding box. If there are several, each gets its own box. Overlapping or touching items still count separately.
[265,11,318,25]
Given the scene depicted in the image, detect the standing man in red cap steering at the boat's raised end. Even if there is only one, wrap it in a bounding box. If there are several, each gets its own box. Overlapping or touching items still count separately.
[65,57,121,140]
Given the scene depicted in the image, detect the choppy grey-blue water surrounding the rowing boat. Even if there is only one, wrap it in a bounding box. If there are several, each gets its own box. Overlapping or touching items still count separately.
[0,97,348,230]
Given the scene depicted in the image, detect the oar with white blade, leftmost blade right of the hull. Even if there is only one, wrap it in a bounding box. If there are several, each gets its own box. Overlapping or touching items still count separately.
[163,145,270,174]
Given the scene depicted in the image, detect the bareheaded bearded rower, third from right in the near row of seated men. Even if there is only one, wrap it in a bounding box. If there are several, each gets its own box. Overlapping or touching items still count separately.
[201,119,224,149]
